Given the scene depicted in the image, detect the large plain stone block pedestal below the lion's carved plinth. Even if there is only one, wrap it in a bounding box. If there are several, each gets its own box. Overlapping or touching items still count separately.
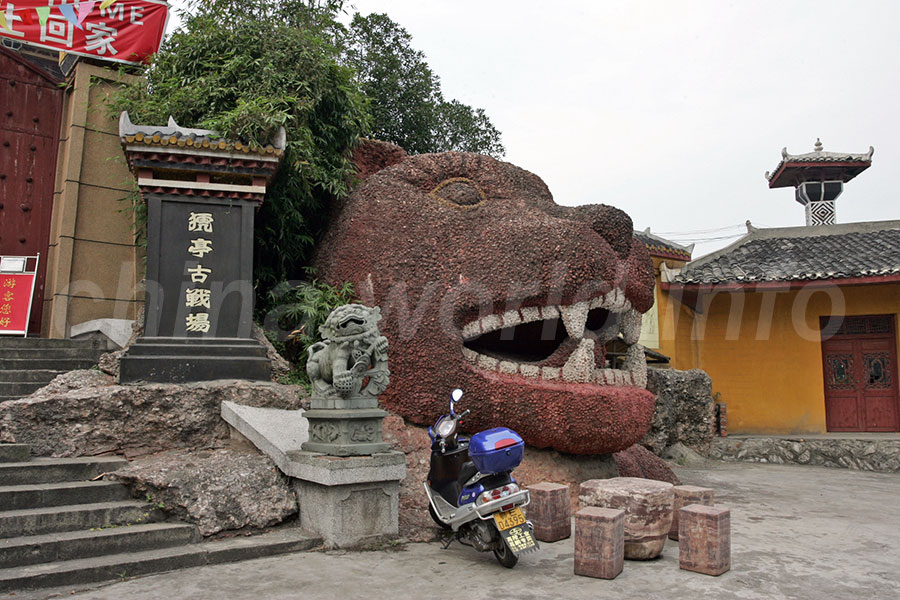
[289,451,406,548]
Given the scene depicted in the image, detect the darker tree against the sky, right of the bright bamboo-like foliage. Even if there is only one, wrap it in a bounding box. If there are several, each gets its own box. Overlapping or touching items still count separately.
[344,13,504,158]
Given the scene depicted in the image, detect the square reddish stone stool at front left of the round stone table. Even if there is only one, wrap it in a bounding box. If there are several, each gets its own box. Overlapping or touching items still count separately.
[575,506,625,579]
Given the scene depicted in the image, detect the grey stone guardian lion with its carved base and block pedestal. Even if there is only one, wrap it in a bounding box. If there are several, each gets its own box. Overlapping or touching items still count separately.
[289,304,406,547]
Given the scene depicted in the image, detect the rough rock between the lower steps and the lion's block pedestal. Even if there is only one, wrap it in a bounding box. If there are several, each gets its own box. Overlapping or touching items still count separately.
[107,448,297,536]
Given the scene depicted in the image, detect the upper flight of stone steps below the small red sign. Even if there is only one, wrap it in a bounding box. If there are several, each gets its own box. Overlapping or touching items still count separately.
[0,337,106,402]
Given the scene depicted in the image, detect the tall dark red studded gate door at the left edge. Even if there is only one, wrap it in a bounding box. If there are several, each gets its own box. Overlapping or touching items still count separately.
[0,48,63,334]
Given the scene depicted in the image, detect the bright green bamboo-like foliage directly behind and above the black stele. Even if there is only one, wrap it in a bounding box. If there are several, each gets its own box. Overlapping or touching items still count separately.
[112,0,369,290]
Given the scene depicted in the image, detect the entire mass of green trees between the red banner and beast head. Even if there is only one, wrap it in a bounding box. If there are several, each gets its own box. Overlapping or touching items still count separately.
[110,0,503,314]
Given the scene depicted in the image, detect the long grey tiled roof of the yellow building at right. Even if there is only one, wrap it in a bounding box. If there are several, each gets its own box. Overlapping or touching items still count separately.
[670,221,900,284]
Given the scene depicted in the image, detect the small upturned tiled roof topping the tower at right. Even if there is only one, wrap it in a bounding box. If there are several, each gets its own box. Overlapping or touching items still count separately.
[766,139,875,188]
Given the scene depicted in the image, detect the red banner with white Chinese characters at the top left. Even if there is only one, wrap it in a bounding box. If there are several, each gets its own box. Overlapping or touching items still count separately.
[0,0,169,63]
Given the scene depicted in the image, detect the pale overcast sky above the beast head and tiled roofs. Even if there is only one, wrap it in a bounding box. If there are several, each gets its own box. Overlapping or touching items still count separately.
[167,0,900,258]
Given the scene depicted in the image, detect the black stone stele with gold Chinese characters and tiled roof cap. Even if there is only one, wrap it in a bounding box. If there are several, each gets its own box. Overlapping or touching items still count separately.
[119,112,285,383]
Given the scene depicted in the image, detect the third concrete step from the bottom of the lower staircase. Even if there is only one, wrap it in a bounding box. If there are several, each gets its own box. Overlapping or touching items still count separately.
[0,500,163,538]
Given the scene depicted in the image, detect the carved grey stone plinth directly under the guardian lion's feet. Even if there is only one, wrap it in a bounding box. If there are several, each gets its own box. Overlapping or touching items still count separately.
[303,408,390,456]
